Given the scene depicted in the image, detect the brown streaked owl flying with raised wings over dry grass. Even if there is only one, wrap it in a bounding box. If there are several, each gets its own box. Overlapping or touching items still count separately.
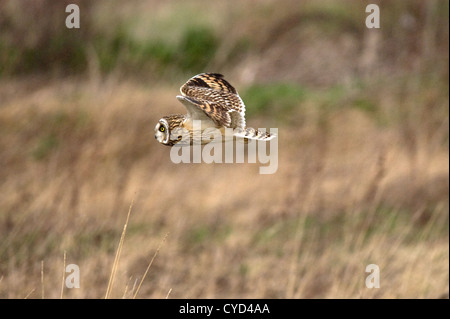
[155,73,275,146]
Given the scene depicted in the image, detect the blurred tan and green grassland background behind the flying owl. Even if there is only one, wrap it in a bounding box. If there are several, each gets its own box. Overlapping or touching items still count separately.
[0,0,449,298]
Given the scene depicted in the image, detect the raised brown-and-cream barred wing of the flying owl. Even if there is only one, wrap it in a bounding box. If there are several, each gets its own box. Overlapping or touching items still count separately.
[177,73,245,129]
